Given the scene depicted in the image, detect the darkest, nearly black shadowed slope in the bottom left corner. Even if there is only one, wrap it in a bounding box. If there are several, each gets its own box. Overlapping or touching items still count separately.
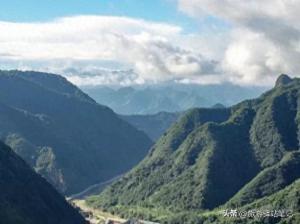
[0,142,85,224]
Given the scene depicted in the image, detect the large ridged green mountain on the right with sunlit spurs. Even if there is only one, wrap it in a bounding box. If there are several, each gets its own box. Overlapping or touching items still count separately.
[88,76,300,223]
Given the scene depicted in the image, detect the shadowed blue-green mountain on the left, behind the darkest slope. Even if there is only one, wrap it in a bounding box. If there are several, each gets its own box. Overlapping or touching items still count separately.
[0,71,152,194]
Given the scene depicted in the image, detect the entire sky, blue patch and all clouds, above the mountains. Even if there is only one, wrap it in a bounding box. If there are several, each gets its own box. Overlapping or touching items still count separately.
[0,0,300,86]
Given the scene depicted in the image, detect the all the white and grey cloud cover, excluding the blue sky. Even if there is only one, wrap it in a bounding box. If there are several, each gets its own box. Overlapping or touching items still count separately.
[0,0,300,85]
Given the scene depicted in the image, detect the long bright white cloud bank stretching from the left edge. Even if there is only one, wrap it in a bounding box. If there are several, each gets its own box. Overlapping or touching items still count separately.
[0,16,220,84]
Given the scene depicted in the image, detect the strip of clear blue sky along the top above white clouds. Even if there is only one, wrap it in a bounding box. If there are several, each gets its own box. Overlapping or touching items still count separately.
[0,0,229,32]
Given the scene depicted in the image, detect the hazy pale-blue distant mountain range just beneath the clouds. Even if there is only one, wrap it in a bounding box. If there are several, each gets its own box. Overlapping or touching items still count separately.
[81,83,265,115]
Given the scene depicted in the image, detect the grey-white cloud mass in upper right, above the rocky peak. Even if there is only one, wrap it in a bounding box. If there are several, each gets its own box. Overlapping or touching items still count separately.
[178,0,300,84]
